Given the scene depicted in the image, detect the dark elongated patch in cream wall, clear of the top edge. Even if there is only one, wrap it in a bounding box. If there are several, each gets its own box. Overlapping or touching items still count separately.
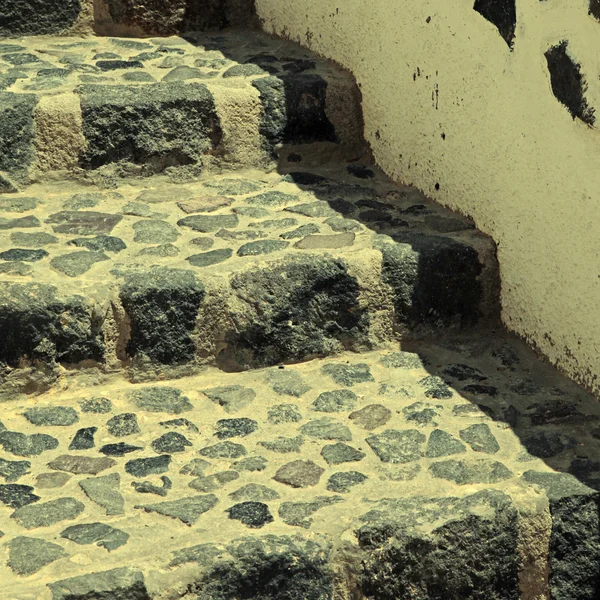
[545,40,596,125]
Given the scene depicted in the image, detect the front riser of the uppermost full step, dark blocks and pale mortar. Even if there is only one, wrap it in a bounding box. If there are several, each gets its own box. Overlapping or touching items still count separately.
[0,75,365,183]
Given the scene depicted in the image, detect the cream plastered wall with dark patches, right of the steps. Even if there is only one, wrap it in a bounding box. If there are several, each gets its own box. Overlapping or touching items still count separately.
[256,0,600,393]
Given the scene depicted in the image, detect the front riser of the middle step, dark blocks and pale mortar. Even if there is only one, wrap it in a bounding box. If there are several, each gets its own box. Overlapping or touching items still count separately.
[0,241,497,395]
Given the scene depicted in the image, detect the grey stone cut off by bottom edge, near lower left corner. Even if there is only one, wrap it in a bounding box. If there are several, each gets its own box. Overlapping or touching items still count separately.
[48,567,150,600]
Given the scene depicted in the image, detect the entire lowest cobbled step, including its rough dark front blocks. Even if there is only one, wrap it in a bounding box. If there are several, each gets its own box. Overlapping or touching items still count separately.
[0,336,600,600]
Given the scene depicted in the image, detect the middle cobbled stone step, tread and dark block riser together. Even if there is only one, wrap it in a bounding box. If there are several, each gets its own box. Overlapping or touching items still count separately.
[0,163,498,397]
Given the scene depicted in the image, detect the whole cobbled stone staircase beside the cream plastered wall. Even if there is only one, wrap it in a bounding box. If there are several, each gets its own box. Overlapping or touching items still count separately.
[0,15,600,600]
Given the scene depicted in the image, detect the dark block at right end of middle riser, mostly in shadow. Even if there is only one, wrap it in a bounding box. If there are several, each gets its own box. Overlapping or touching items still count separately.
[380,232,483,328]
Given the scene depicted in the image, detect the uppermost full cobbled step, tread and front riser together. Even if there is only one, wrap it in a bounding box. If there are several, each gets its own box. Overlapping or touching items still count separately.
[0,31,365,187]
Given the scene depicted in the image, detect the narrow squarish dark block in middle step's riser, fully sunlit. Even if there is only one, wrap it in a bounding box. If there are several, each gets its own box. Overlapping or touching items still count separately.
[120,268,205,364]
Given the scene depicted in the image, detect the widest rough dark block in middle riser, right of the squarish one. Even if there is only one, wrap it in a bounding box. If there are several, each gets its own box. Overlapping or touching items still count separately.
[224,256,366,366]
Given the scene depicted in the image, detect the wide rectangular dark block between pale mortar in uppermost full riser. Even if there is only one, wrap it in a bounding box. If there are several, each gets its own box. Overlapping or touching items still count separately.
[79,82,222,169]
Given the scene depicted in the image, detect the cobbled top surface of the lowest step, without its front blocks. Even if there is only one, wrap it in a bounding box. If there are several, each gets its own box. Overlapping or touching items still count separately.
[0,333,600,600]
